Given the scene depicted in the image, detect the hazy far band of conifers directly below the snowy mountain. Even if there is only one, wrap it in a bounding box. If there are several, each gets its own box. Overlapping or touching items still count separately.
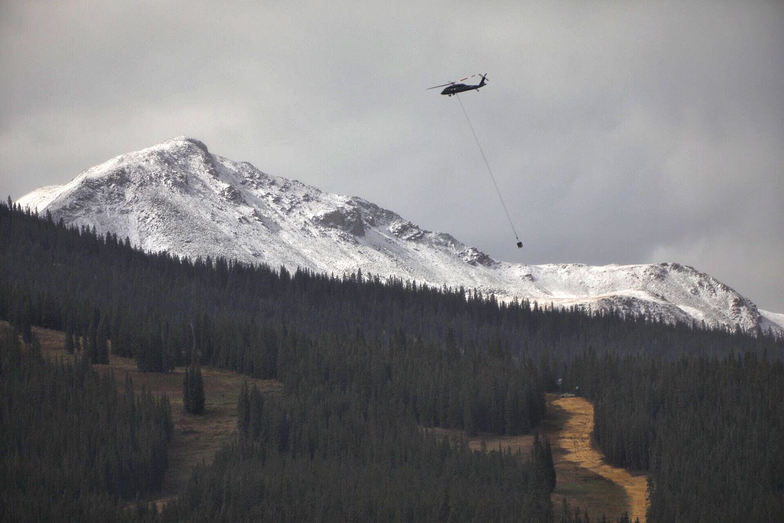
[0,204,782,378]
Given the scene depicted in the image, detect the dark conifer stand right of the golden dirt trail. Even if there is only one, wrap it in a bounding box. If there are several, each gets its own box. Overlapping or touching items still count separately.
[569,352,784,521]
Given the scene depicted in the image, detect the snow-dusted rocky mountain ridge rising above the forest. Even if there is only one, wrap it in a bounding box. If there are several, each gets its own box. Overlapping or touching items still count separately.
[17,137,784,333]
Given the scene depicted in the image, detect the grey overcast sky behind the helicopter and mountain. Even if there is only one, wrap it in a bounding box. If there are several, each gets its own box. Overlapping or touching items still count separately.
[0,0,784,312]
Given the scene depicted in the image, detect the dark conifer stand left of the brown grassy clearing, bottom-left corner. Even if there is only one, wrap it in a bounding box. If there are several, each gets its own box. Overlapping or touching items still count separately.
[0,328,172,521]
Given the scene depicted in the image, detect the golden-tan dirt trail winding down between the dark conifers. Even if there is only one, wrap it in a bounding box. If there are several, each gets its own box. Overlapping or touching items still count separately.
[550,397,648,522]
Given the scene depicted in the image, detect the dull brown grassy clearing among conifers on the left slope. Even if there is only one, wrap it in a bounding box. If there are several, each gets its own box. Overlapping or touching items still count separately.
[33,327,283,506]
